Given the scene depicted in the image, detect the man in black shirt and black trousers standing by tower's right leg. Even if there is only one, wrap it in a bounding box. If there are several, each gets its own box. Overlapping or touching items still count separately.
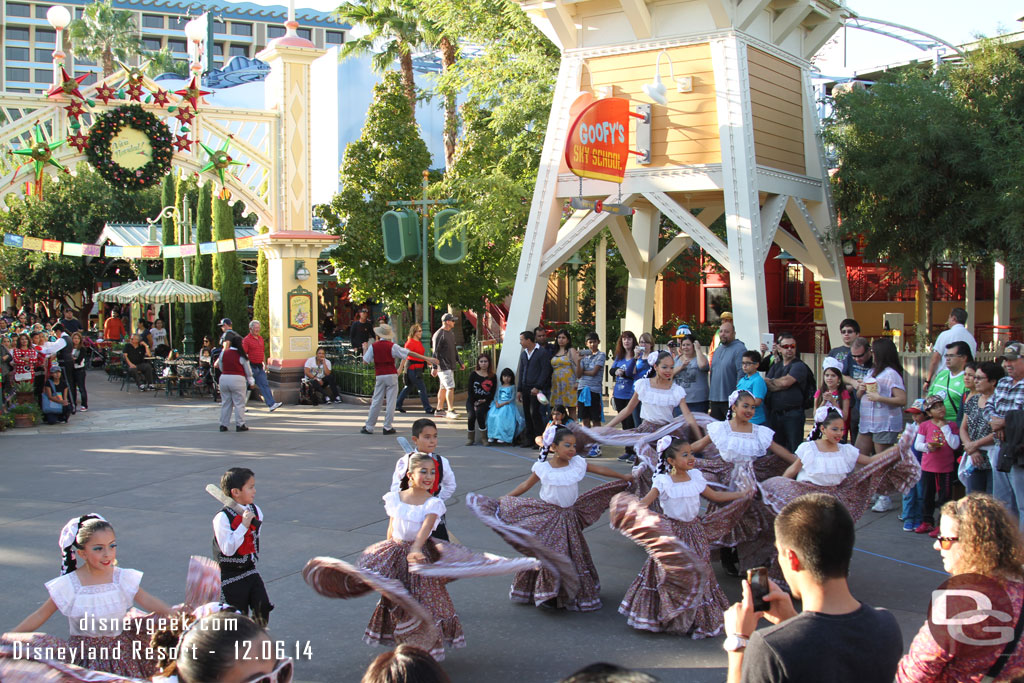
[765,333,814,452]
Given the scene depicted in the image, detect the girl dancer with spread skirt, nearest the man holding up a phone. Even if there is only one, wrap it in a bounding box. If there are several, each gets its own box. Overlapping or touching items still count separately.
[611,436,754,639]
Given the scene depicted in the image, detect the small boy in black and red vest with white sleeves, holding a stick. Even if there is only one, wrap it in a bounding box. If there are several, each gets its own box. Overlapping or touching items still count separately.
[213,467,273,626]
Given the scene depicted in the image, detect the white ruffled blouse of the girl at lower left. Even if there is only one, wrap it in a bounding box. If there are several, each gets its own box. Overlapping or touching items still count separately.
[46,567,142,637]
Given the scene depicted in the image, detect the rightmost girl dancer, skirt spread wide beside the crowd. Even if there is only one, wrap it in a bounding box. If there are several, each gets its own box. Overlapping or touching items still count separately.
[760,405,920,521]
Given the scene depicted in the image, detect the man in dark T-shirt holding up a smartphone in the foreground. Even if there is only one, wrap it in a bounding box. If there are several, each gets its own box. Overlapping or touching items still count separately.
[723,494,903,683]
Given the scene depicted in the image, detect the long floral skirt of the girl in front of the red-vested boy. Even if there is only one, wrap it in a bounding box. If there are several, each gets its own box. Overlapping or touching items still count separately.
[359,541,466,661]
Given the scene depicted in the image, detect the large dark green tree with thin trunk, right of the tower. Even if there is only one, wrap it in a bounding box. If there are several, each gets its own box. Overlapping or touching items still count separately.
[824,67,992,339]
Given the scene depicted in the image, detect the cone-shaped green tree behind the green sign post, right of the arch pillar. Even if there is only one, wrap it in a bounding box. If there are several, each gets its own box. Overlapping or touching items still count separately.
[317,72,430,309]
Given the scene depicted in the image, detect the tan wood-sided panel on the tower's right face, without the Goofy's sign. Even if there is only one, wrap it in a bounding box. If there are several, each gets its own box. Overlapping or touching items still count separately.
[746,47,806,174]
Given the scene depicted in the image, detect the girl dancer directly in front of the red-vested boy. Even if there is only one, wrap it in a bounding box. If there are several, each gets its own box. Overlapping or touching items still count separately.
[359,453,466,660]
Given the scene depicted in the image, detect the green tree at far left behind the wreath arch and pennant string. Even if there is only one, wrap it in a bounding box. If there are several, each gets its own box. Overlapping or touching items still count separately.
[0,163,160,321]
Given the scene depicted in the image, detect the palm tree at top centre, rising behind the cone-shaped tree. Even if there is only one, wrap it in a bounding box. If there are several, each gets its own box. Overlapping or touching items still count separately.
[334,0,424,112]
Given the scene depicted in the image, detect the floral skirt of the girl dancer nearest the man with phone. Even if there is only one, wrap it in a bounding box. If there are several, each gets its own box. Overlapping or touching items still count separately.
[618,491,751,640]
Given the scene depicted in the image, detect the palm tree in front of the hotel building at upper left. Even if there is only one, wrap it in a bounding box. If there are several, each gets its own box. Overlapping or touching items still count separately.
[68,0,145,78]
